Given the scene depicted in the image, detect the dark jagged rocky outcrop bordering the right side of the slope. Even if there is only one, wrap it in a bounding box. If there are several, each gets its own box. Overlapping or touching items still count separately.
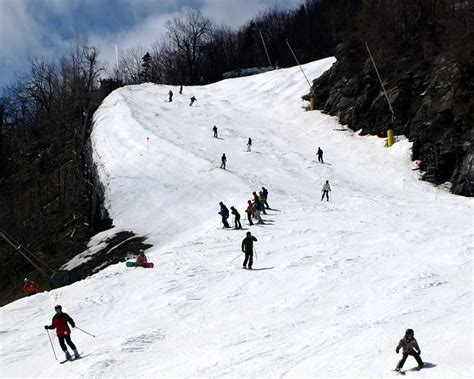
[306,42,474,196]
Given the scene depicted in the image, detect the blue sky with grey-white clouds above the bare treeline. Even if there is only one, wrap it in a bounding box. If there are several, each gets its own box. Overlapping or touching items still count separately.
[0,0,301,87]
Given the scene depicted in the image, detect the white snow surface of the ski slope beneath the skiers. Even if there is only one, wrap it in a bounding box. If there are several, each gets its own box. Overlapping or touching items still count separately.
[0,58,474,378]
